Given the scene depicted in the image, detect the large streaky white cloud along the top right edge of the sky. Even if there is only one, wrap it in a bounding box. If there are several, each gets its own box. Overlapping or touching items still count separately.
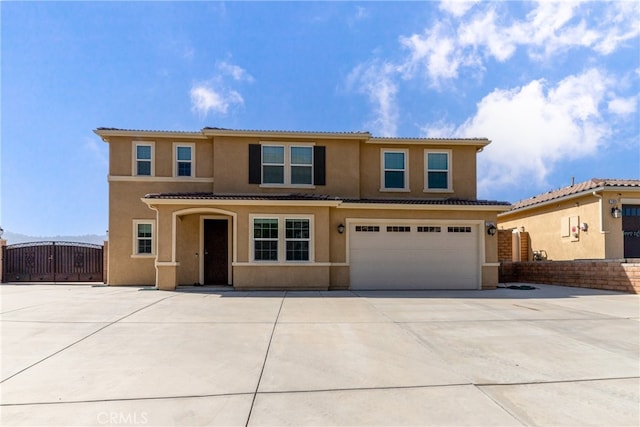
[399,1,640,88]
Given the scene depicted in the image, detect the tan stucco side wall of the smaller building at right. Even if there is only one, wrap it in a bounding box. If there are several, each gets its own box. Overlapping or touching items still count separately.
[499,194,608,260]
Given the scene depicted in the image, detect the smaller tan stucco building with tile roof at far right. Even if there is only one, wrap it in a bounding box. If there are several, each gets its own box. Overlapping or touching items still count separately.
[498,178,640,261]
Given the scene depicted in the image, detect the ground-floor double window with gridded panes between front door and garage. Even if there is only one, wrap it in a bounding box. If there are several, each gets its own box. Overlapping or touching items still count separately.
[251,215,313,262]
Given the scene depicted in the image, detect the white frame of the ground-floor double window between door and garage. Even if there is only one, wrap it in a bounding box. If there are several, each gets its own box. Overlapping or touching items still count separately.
[249,214,315,265]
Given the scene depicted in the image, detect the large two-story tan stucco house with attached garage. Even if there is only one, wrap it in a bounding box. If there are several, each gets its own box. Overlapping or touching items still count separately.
[95,128,509,289]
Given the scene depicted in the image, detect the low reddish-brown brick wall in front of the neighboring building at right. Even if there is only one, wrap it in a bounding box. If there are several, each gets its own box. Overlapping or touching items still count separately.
[499,260,640,294]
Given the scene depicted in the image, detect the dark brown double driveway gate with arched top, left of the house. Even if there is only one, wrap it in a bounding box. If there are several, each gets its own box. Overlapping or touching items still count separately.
[2,242,103,282]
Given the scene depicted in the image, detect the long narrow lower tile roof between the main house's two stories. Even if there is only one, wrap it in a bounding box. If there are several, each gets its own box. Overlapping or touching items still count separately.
[144,193,510,206]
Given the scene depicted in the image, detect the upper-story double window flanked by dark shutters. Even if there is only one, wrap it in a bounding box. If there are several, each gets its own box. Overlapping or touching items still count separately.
[249,143,325,187]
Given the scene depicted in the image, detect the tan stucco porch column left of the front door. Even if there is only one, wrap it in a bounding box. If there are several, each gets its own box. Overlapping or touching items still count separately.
[156,207,180,291]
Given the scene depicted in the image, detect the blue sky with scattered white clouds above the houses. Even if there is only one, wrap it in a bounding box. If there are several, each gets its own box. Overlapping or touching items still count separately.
[0,1,640,236]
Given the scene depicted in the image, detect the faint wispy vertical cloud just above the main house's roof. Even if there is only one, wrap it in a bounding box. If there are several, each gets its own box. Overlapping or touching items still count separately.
[348,63,399,136]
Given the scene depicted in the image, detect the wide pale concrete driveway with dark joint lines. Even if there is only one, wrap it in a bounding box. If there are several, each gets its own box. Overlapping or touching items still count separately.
[0,285,640,426]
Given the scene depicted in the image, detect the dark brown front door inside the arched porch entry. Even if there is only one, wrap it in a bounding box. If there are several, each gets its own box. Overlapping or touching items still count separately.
[204,219,229,285]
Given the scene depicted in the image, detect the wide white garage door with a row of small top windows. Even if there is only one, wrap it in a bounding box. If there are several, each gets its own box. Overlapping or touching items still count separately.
[349,223,480,289]
